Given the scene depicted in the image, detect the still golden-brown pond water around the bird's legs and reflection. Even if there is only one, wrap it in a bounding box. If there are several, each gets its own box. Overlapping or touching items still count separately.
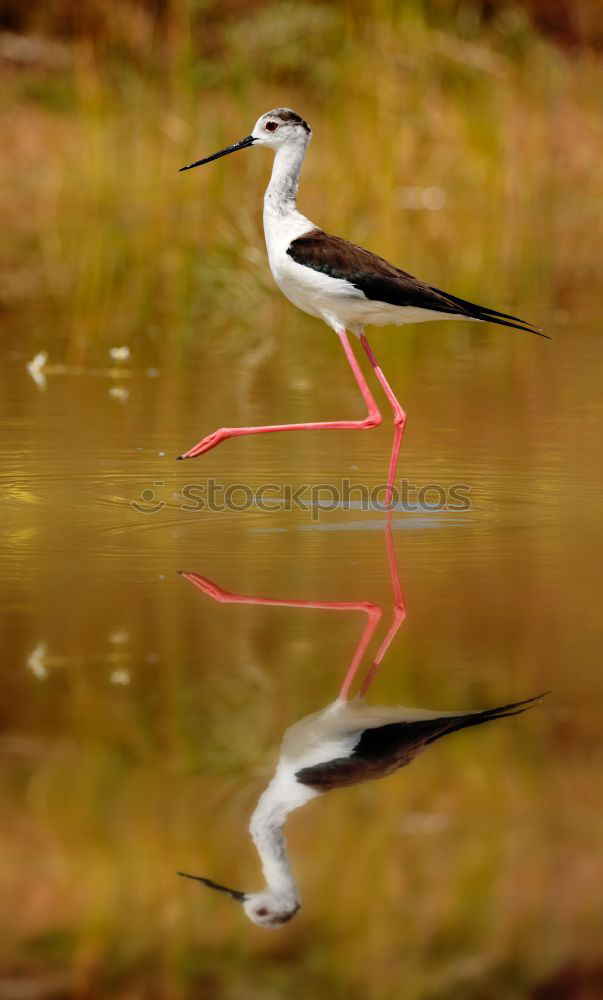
[0,308,603,1000]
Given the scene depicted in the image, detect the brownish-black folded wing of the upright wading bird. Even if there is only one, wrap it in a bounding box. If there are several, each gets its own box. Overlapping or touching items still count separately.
[287,229,548,339]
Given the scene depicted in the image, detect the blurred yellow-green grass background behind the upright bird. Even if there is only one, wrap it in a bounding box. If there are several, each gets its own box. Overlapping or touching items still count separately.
[0,0,603,365]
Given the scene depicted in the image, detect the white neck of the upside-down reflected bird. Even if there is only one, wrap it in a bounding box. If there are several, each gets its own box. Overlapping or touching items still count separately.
[249,782,299,908]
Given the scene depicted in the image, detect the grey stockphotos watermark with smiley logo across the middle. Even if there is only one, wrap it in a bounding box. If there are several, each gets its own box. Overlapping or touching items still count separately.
[130,479,471,521]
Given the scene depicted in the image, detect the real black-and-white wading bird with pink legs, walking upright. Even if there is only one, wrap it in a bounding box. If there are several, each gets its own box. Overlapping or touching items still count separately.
[179,108,546,506]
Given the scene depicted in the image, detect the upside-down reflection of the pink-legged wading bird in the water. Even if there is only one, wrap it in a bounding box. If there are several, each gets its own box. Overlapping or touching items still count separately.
[178,523,543,927]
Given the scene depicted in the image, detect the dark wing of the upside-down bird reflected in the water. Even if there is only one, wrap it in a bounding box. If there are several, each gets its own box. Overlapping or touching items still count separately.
[295,694,544,792]
